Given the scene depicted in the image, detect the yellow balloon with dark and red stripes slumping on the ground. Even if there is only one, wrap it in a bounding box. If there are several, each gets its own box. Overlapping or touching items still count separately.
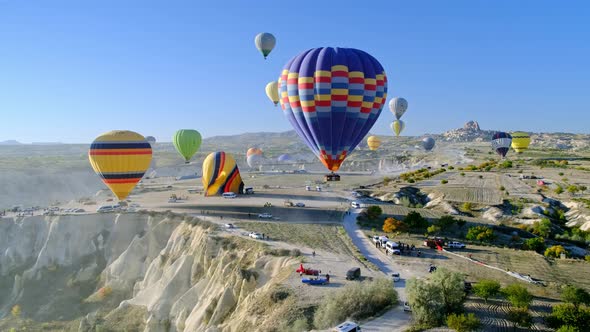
[202,151,244,196]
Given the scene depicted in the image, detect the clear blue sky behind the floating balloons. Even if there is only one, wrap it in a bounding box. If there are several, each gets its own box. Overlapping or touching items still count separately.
[0,0,590,142]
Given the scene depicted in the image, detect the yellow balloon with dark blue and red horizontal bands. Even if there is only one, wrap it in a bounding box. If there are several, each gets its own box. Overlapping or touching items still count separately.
[88,130,152,200]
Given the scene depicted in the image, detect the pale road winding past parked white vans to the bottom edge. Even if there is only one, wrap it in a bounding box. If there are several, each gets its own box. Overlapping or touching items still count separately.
[343,209,417,332]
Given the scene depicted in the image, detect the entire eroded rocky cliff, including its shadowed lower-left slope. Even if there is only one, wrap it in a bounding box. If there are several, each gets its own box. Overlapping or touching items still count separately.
[0,214,296,331]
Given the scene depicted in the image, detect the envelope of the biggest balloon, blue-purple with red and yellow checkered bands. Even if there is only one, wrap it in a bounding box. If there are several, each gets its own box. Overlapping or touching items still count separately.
[279,47,387,172]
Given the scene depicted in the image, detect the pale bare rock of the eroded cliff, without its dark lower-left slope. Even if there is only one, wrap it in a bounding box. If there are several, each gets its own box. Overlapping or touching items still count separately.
[0,213,297,332]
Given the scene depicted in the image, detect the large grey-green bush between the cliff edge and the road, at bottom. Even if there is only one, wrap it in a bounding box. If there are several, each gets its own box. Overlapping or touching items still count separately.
[314,279,398,329]
